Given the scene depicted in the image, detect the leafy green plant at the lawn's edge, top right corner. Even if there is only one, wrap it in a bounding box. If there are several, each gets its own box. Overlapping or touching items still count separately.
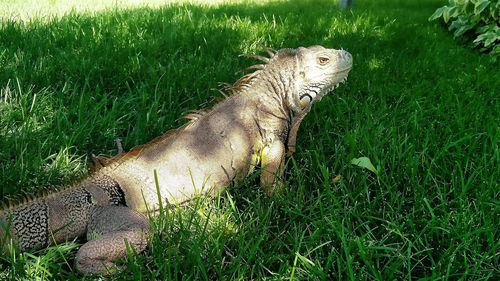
[429,0,500,55]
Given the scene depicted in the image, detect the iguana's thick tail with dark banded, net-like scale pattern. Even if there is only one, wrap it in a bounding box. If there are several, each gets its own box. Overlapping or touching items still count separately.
[0,175,124,251]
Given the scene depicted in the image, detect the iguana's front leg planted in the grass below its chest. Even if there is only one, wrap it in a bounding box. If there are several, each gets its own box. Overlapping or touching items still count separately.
[260,140,285,194]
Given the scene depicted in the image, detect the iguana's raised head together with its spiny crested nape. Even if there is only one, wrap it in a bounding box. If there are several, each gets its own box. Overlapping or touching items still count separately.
[233,46,352,113]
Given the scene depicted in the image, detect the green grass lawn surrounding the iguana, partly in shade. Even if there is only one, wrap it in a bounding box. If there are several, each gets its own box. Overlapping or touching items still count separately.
[0,0,500,280]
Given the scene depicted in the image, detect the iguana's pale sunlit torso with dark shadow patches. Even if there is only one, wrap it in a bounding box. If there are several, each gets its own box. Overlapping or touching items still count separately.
[99,93,270,212]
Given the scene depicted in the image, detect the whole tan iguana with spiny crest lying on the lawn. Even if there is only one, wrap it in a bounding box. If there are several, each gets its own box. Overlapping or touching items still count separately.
[0,46,352,273]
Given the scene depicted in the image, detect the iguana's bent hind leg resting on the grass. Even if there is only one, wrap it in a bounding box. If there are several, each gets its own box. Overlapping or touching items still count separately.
[76,206,149,274]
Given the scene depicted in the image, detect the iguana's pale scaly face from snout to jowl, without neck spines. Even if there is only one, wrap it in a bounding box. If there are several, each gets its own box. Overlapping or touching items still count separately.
[291,46,352,110]
